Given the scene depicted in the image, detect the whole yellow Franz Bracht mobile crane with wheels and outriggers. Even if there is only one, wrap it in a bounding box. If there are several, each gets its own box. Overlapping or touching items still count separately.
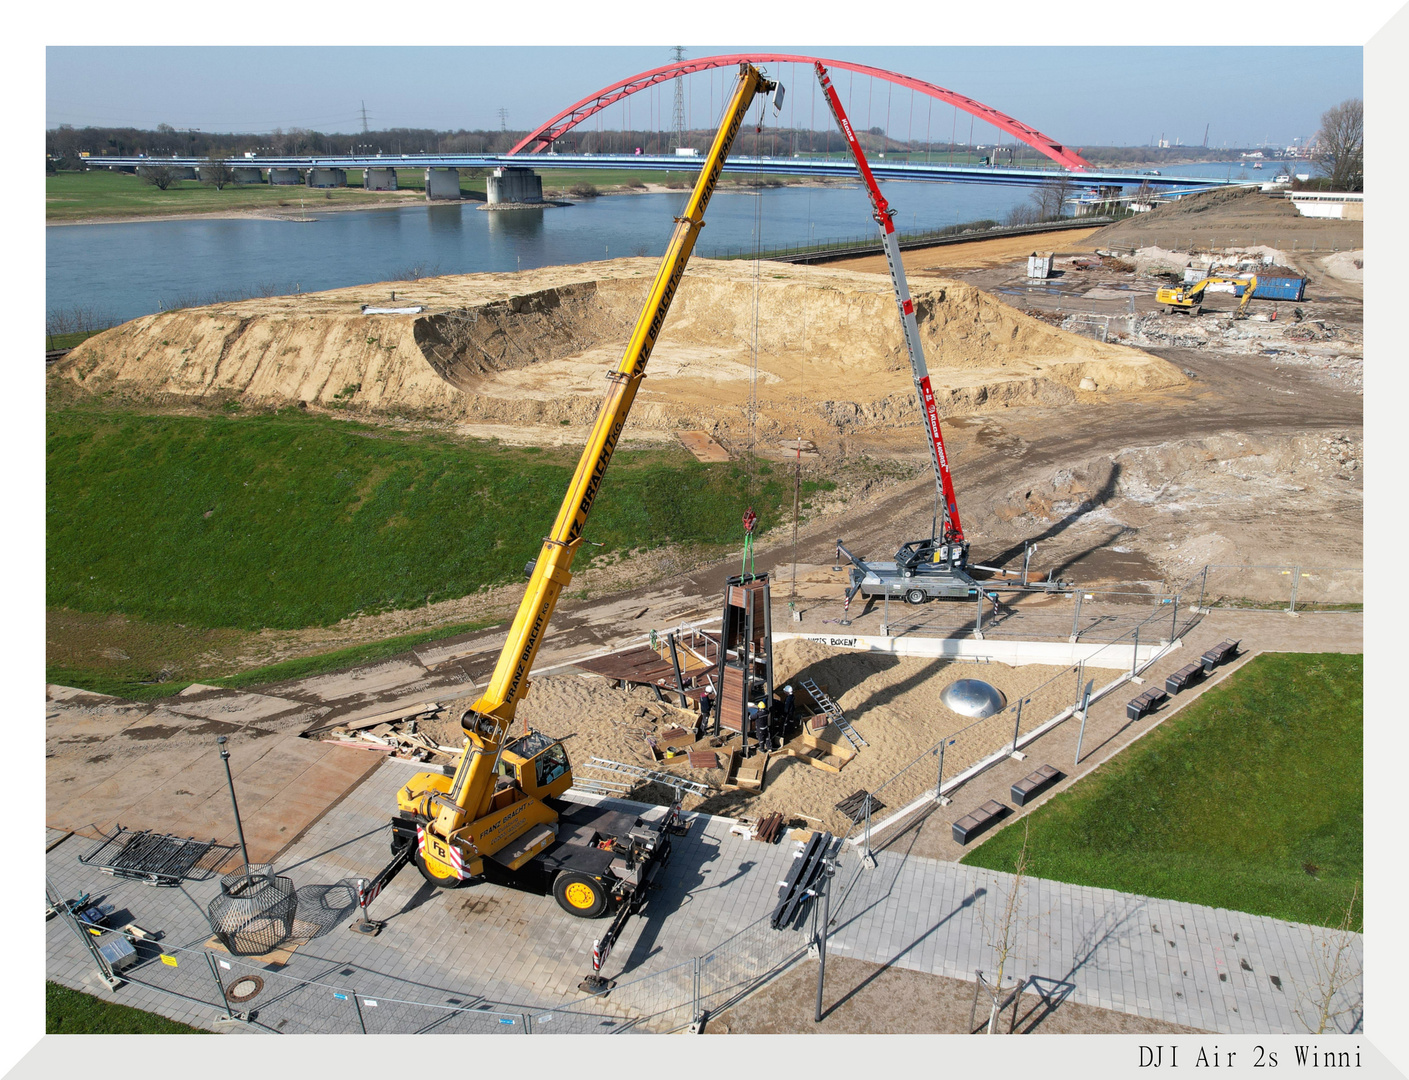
[342,63,783,990]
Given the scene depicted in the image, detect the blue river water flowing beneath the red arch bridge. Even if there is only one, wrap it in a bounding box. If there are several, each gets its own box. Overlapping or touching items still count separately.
[45,162,1256,320]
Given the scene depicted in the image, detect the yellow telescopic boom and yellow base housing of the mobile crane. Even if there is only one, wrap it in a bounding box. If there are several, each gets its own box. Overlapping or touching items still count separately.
[399,63,776,877]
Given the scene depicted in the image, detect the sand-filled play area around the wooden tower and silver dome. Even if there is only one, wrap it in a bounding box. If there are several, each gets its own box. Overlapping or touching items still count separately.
[421,639,1082,835]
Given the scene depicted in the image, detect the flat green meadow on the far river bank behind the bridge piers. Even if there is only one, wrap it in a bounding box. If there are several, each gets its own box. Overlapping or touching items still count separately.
[45,169,727,224]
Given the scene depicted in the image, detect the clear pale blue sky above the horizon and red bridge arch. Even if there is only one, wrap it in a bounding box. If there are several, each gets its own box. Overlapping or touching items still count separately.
[45,45,1364,146]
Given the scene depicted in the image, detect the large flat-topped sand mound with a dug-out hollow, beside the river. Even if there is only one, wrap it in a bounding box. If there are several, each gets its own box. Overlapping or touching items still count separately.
[52,259,1184,434]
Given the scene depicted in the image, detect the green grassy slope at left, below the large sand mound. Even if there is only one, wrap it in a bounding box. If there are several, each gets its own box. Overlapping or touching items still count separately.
[46,408,831,697]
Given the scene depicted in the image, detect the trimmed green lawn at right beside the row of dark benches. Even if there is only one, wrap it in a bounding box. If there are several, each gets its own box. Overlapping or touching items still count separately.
[964,653,1364,929]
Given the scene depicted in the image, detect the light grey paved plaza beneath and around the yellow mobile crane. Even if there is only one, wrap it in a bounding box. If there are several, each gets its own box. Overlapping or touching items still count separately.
[48,760,1361,1034]
